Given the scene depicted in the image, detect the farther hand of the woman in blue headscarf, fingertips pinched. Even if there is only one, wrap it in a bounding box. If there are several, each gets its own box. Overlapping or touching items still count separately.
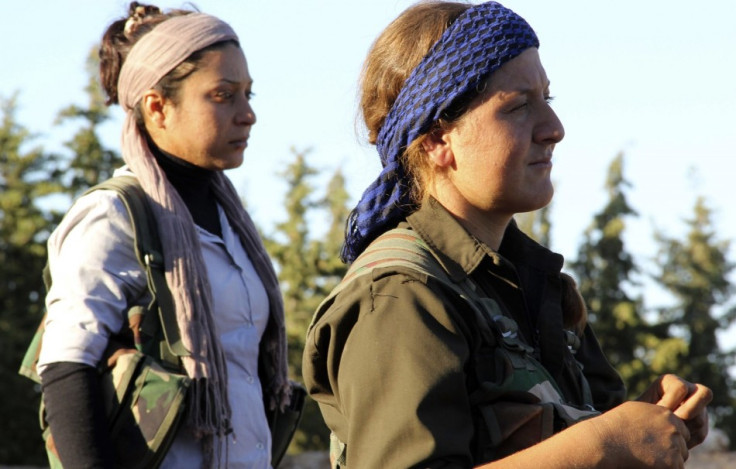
[637,374,713,448]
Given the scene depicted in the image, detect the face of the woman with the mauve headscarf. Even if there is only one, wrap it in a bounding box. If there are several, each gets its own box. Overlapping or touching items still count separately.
[153,44,256,170]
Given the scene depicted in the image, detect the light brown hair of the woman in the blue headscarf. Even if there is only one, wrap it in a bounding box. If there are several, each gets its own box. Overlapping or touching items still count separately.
[360,1,472,203]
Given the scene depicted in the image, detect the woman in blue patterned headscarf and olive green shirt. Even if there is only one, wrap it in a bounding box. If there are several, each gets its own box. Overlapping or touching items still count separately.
[304,2,711,469]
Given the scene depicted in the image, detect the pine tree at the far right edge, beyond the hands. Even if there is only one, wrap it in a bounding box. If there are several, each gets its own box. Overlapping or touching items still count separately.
[655,198,736,444]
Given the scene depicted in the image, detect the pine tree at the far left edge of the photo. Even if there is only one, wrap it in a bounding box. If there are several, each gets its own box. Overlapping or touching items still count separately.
[0,93,61,464]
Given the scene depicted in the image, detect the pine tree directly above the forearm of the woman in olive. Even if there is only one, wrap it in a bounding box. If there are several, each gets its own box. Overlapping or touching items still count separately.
[571,154,657,396]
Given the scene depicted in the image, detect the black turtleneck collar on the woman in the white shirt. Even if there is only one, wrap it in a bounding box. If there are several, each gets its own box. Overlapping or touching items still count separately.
[151,145,222,237]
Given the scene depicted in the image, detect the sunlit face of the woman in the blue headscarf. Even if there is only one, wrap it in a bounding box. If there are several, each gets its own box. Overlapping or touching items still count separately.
[440,48,564,219]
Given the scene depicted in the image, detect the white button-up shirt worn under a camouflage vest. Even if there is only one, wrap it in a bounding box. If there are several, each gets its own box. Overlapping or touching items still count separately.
[38,176,271,469]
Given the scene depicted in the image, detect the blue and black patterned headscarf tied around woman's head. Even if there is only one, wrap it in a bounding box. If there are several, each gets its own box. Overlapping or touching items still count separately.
[342,2,539,262]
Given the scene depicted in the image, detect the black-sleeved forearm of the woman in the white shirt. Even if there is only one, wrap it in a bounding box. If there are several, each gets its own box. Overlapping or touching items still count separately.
[41,362,113,468]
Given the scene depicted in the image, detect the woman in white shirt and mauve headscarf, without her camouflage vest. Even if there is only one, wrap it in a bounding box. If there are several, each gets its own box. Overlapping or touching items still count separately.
[38,2,289,469]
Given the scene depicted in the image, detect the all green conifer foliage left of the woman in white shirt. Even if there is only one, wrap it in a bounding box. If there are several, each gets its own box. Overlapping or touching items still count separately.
[0,45,121,464]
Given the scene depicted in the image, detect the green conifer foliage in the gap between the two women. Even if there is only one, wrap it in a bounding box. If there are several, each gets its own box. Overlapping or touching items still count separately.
[264,150,348,452]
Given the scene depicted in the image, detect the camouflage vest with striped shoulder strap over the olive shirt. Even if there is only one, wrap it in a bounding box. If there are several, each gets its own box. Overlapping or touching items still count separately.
[310,228,599,468]
